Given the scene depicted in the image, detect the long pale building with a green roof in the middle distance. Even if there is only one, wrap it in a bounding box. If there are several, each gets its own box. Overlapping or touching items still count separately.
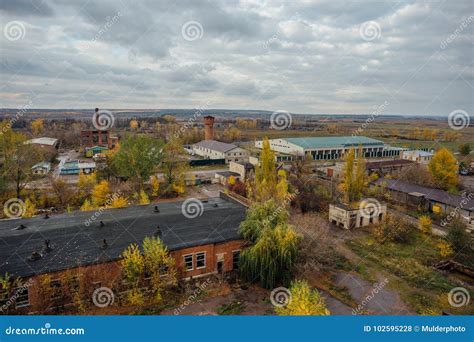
[255,136,402,160]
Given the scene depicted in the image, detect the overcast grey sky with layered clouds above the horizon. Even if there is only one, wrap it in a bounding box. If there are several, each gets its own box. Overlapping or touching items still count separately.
[0,0,474,115]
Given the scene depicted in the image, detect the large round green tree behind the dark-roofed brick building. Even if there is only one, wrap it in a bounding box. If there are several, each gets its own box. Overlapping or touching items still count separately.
[112,136,163,189]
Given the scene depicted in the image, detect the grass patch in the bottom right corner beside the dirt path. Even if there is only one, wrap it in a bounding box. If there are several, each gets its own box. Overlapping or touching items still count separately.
[346,232,473,315]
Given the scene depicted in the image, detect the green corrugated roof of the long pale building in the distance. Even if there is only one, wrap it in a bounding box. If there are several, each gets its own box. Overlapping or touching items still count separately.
[283,136,384,149]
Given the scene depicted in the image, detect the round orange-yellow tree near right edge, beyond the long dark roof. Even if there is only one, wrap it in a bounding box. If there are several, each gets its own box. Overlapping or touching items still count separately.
[428,148,458,192]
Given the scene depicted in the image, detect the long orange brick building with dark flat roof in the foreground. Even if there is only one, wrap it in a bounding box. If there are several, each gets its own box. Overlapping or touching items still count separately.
[0,197,245,313]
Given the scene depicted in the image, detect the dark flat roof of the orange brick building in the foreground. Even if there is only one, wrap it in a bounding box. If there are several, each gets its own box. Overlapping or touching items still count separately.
[0,197,245,277]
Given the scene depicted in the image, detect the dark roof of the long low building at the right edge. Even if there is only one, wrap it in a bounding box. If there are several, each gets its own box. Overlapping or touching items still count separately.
[375,178,474,211]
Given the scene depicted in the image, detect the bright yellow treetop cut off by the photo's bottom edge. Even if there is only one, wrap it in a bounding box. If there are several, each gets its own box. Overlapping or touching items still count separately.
[275,280,329,316]
